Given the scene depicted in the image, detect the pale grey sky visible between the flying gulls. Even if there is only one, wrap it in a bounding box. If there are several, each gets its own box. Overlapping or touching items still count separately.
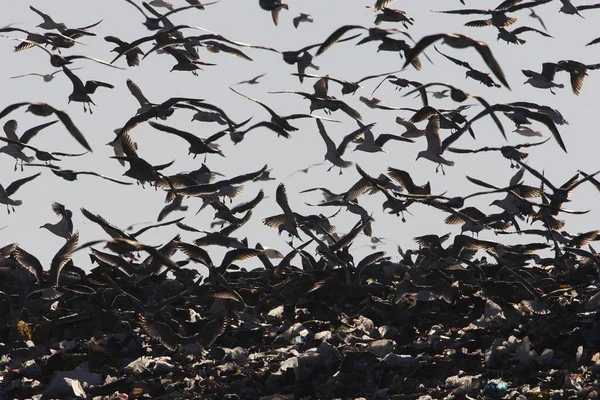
[0,0,600,271]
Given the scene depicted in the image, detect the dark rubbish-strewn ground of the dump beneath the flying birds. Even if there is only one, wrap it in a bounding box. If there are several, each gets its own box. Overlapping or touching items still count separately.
[0,257,600,399]
